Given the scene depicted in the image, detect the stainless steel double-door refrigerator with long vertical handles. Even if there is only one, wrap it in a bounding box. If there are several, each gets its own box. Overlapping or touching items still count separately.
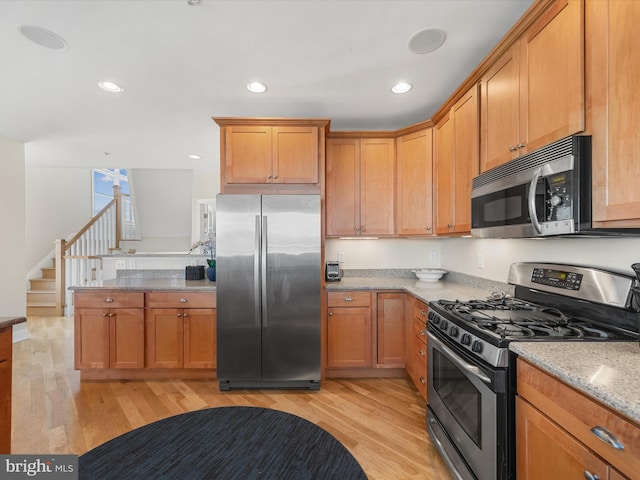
[216,194,322,390]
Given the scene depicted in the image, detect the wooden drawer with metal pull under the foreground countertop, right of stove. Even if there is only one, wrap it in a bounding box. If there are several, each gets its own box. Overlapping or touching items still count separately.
[517,359,640,478]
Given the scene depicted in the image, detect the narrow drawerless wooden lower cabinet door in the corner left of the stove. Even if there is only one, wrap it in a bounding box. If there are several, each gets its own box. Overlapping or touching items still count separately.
[378,293,406,367]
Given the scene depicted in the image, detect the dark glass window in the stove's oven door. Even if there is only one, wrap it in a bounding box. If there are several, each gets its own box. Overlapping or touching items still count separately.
[432,350,482,447]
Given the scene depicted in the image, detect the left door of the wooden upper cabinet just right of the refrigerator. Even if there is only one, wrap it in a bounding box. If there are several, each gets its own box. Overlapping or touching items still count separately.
[326,139,360,236]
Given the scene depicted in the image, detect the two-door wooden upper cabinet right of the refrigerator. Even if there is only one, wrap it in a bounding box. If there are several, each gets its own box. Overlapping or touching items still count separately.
[326,138,395,236]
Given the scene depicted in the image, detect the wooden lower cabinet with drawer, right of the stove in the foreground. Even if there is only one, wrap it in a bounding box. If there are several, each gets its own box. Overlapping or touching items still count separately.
[516,359,640,480]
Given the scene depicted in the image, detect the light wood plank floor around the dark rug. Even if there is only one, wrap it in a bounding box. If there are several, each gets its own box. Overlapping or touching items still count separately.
[12,317,451,480]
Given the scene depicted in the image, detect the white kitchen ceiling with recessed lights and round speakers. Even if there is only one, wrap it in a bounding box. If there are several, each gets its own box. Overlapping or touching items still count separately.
[0,0,532,170]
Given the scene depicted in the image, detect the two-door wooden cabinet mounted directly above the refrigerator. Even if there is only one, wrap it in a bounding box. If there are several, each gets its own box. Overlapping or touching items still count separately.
[214,118,329,193]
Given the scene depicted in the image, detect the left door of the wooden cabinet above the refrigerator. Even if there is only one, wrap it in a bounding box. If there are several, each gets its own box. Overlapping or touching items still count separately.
[225,125,273,183]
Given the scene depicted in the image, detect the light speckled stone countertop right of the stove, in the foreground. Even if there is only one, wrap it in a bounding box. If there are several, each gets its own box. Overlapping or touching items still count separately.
[509,342,640,423]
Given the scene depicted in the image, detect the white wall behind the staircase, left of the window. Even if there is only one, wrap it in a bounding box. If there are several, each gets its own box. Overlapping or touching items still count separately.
[23,168,92,268]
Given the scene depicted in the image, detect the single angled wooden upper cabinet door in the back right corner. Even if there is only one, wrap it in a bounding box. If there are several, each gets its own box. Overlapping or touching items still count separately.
[396,128,434,236]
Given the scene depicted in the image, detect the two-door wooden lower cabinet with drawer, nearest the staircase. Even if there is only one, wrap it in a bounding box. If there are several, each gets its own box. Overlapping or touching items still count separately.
[74,291,144,370]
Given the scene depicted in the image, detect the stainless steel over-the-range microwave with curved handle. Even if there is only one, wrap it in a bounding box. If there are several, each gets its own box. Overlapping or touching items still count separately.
[471,136,592,238]
